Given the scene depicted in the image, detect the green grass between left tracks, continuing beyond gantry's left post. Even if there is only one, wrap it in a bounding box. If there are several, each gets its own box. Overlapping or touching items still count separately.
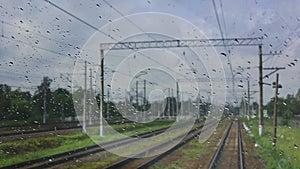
[0,121,173,167]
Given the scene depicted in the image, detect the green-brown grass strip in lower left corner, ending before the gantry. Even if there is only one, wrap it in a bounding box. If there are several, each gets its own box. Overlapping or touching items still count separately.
[0,133,94,167]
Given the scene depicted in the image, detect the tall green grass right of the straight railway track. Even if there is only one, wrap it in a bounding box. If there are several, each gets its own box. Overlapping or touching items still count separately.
[244,119,300,169]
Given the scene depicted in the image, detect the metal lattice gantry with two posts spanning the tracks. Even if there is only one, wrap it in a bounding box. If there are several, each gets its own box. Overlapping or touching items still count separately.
[100,37,263,136]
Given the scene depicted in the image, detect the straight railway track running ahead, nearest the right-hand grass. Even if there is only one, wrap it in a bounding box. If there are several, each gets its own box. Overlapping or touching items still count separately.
[208,120,244,169]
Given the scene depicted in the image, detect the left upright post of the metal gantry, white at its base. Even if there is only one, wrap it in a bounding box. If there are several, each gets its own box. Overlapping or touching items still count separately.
[99,49,104,137]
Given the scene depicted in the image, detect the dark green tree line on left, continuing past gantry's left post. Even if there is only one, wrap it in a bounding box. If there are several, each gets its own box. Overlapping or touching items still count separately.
[0,77,122,125]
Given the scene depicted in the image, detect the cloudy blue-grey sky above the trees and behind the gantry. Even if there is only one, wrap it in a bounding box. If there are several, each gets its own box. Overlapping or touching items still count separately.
[0,0,300,105]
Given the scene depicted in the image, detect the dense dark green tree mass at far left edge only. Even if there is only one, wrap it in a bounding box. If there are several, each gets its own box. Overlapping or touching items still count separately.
[0,77,76,123]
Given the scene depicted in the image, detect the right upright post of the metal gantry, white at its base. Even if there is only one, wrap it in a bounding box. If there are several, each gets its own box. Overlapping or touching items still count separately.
[258,45,264,136]
